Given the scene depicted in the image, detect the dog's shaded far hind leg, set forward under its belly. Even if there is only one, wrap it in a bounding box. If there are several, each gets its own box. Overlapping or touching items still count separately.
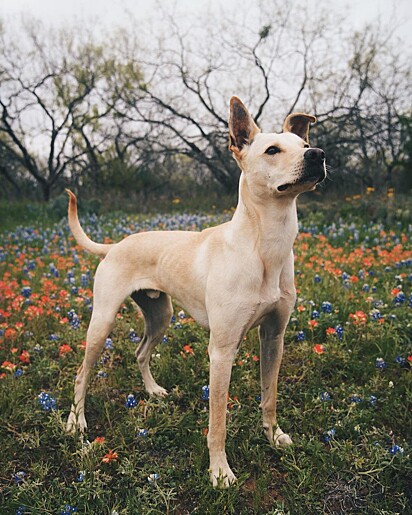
[132,290,173,397]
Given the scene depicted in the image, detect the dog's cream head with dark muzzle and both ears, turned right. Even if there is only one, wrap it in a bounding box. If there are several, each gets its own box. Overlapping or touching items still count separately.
[229,97,326,197]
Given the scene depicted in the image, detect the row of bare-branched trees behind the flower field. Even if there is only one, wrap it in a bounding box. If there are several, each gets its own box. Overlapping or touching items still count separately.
[0,0,412,202]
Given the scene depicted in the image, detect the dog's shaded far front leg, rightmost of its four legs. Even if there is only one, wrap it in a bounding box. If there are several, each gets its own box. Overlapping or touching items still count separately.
[259,295,295,447]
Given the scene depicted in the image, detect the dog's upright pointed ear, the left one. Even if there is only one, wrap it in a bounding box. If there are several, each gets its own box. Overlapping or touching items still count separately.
[229,97,260,152]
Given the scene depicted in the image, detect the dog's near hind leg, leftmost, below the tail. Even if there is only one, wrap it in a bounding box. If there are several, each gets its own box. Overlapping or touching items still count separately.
[66,261,130,433]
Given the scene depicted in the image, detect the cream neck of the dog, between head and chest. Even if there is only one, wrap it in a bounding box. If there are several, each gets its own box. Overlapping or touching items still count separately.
[231,173,298,262]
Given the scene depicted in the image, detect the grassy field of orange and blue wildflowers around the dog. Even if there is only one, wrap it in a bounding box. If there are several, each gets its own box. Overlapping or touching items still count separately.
[0,207,412,515]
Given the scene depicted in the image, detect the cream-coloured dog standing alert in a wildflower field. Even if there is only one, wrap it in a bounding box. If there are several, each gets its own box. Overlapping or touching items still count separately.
[66,97,326,487]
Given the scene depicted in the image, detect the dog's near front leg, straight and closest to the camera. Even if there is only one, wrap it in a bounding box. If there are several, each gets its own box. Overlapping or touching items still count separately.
[207,333,240,487]
